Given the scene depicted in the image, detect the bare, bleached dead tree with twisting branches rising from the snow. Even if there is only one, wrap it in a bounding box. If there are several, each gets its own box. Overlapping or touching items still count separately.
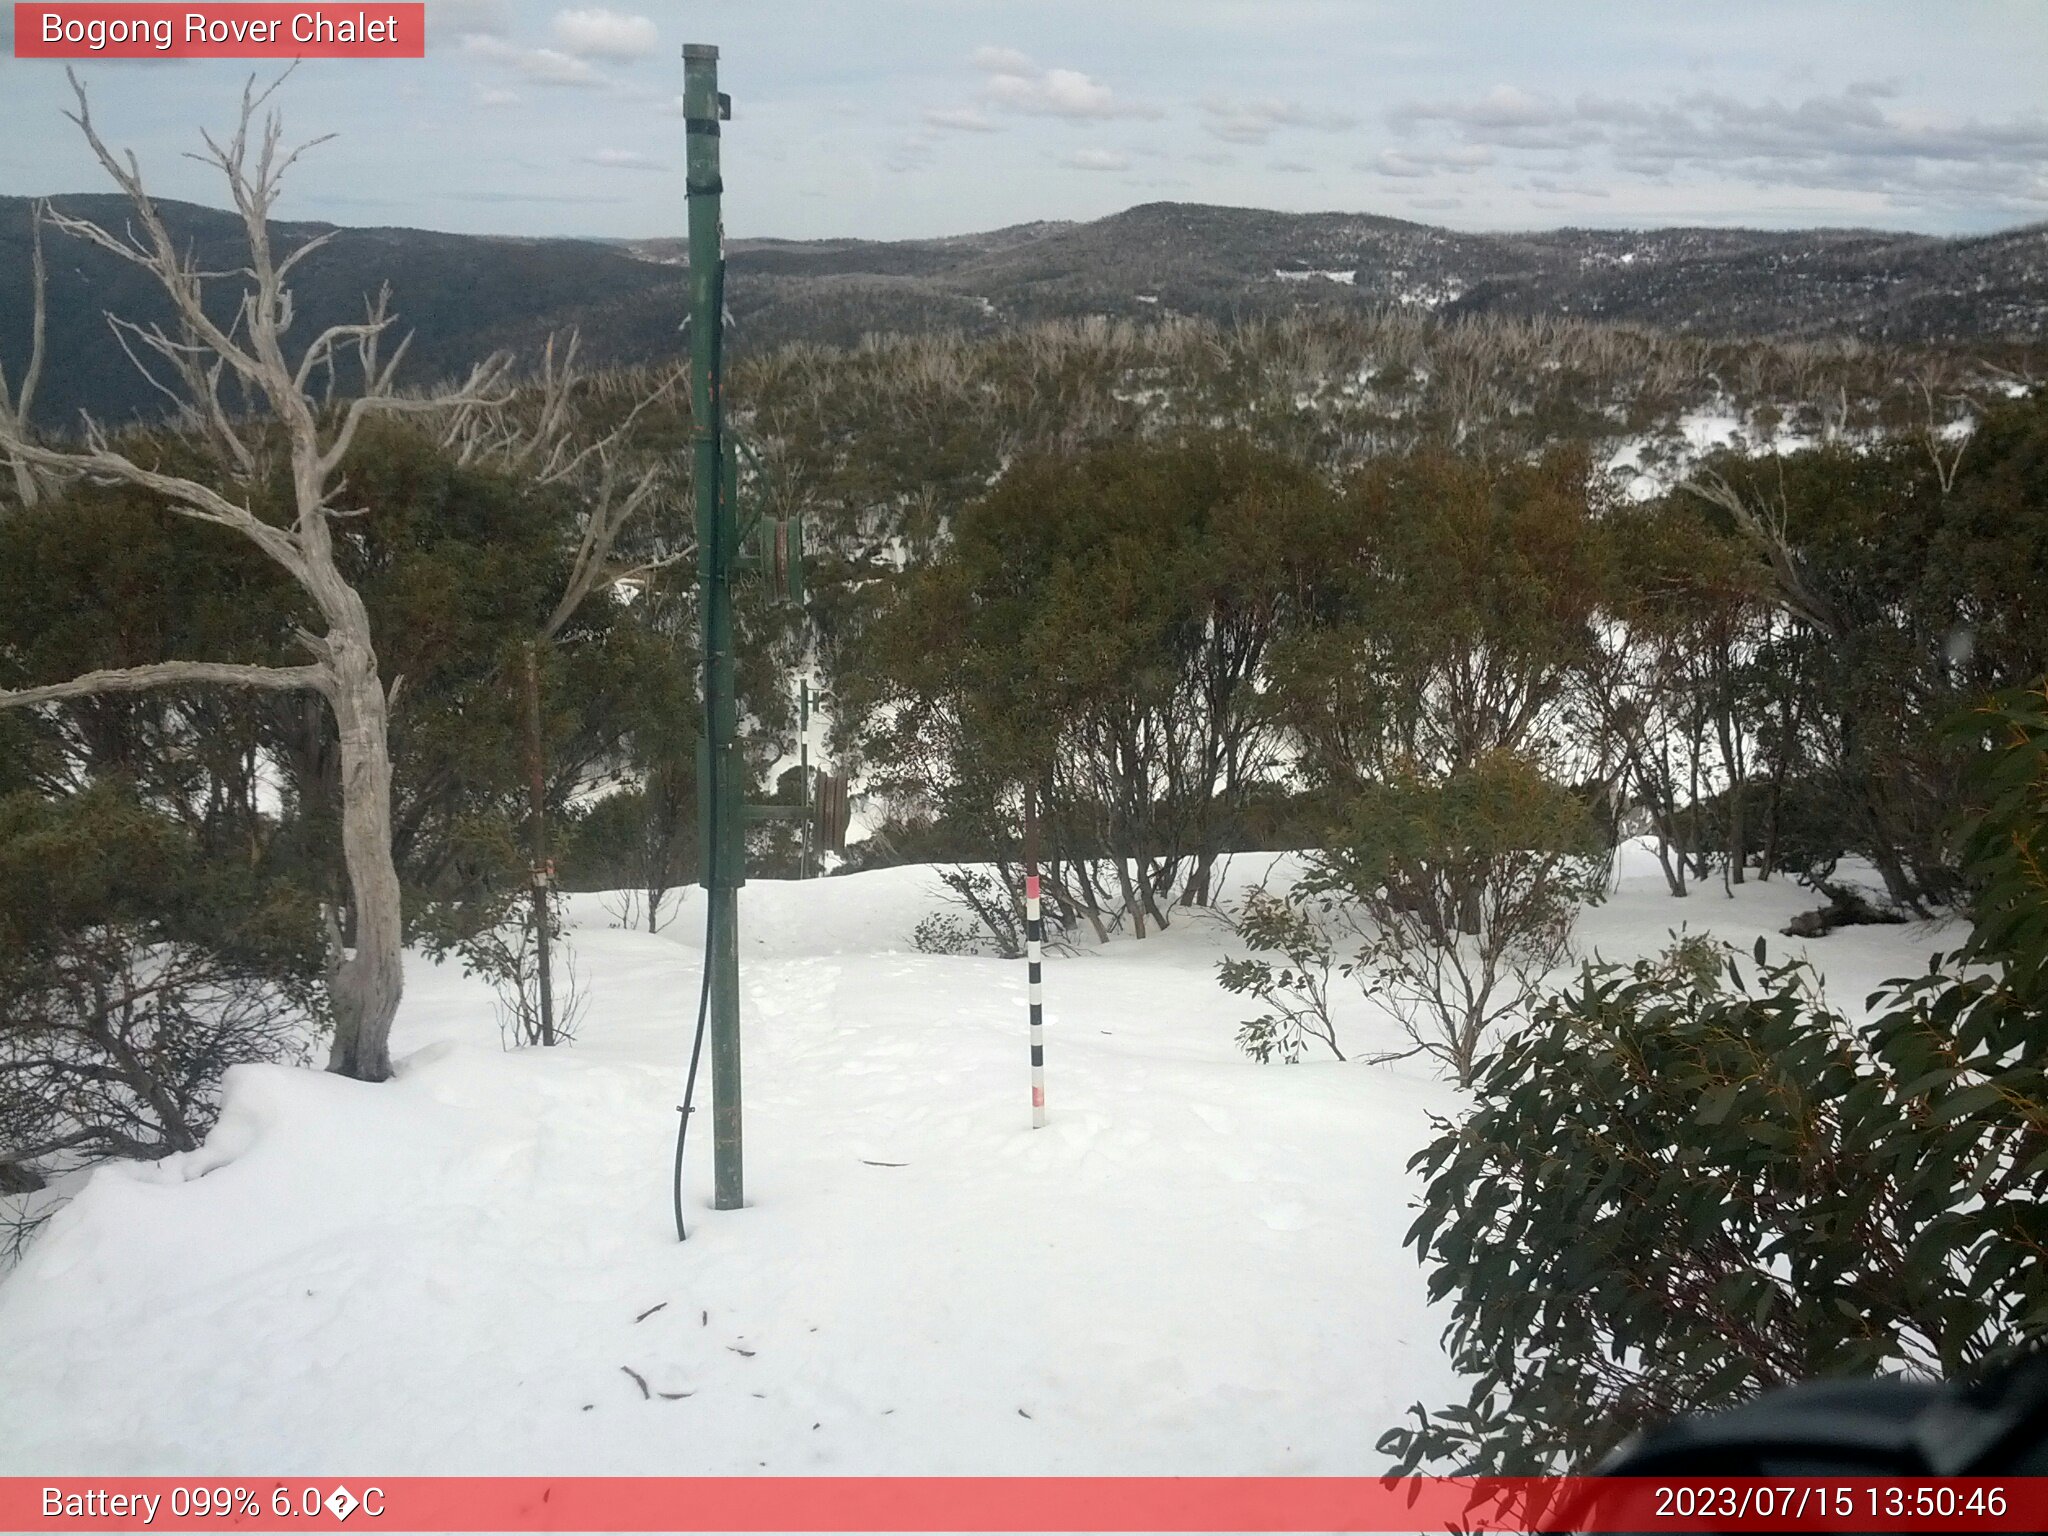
[0,78,504,1081]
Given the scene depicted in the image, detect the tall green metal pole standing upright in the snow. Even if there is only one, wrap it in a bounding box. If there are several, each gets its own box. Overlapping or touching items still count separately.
[682,43,745,1210]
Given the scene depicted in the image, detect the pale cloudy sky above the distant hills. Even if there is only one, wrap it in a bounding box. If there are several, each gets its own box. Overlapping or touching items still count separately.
[0,0,2048,238]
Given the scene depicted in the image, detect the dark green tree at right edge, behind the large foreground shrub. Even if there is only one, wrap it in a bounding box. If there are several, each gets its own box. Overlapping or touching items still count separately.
[1687,393,2048,911]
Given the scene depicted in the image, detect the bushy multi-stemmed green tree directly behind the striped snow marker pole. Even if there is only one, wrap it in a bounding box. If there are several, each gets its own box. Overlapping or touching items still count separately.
[860,436,1329,934]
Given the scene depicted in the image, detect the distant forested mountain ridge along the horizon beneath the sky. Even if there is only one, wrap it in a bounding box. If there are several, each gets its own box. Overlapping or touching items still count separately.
[0,195,2048,422]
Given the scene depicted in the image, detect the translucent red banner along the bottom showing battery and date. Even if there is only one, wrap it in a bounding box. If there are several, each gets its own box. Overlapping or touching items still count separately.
[0,1477,2048,1532]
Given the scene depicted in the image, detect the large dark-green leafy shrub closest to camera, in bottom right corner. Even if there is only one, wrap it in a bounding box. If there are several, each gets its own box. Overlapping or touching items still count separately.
[1380,688,2048,1473]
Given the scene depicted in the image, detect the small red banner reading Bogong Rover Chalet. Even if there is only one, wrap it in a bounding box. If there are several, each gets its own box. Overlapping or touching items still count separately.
[14,0,426,59]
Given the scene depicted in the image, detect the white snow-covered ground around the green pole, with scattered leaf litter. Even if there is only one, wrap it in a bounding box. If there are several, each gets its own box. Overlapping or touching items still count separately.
[0,850,1944,1475]
